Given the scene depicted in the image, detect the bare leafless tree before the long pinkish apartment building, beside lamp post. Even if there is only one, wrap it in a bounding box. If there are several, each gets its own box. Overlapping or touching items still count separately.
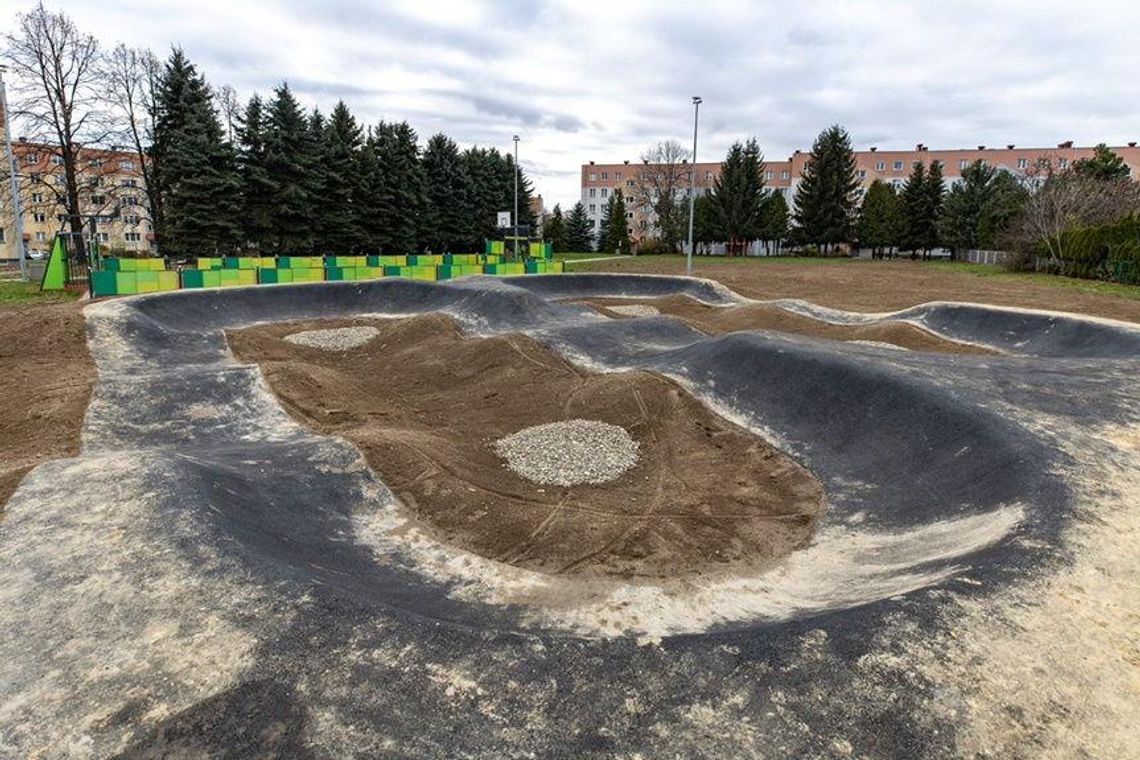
[627,140,701,251]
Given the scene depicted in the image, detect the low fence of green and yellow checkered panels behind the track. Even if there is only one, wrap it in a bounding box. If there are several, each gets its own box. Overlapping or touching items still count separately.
[91,254,563,297]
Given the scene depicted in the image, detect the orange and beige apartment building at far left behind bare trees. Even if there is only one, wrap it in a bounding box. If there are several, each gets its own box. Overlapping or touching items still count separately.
[0,138,155,261]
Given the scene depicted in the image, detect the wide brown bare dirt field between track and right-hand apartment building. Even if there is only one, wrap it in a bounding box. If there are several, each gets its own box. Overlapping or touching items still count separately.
[570,256,1140,321]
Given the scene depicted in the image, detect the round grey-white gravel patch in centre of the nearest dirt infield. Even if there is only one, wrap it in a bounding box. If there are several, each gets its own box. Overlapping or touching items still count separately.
[495,419,637,485]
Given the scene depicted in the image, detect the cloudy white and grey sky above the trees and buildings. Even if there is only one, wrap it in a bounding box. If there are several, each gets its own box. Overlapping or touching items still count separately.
[11,0,1140,205]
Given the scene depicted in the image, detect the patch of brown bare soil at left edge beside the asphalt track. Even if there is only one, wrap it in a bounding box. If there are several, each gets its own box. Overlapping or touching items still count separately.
[0,303,95,509]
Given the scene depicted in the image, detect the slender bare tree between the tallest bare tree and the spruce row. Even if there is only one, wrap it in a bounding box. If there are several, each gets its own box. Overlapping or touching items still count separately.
[101,43,162,229]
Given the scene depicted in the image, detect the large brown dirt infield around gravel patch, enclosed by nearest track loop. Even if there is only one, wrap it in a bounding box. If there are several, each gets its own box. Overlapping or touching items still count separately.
[229,314,823,578]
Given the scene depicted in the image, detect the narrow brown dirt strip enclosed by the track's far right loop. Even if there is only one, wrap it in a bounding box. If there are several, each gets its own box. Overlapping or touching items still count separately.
[579,295,994,353]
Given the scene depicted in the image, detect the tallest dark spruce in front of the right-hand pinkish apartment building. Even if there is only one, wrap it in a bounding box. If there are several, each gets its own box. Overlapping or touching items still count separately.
[796,124,858,252]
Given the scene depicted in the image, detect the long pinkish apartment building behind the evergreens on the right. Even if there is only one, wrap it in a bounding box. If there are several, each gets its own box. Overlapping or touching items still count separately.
[581,142,1140,239]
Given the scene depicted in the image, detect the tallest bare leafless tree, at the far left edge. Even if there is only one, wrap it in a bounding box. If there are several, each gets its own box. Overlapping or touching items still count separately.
[6,3,109,255]
